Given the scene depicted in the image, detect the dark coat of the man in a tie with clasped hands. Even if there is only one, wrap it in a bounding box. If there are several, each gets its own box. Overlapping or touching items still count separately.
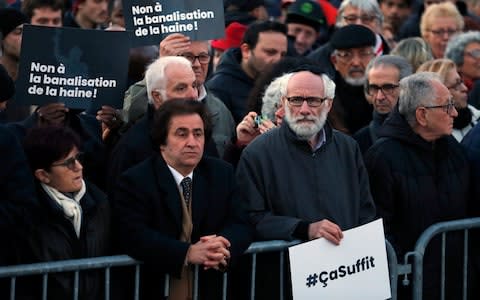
[113,155,253,299]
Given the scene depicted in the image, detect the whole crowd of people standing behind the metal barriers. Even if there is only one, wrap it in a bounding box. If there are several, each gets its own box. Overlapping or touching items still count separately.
[0,0,480,300]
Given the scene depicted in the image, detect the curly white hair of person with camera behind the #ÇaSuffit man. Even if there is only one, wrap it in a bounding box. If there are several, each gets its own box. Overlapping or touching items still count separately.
[262,73,293,120]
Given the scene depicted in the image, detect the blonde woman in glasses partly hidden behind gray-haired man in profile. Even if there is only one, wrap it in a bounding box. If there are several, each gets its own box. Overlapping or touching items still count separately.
[418,58,480,142]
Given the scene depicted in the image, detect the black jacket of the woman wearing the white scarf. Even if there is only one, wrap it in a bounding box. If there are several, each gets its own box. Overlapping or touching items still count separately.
[17,182,111,300]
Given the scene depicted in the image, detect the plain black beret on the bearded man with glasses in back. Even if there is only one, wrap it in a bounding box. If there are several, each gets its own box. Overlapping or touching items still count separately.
[330,24,377,49]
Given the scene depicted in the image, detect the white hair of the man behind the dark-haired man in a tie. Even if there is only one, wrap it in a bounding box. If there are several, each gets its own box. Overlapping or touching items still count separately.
[145,56,193,103]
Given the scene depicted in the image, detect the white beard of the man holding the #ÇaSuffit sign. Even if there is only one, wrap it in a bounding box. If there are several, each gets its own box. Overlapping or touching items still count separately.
[284,105,328,141]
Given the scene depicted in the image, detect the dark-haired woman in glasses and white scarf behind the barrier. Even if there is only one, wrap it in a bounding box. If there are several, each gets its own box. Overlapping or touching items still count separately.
[21,126,110,299]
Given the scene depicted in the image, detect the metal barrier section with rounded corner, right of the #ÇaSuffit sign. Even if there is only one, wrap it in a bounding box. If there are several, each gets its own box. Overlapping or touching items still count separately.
[405,218,480,300]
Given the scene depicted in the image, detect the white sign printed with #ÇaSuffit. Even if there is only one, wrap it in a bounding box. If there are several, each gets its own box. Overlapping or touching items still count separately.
[289,219,391,300]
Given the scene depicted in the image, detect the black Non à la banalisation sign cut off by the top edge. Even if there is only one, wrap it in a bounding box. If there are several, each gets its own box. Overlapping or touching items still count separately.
[123,0,225,46]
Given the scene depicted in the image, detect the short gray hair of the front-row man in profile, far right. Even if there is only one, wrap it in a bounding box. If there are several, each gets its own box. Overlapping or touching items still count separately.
[398,72,442,127]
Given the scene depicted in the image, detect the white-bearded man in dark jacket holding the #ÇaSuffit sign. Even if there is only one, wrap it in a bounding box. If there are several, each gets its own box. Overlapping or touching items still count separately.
[236,67,375,245]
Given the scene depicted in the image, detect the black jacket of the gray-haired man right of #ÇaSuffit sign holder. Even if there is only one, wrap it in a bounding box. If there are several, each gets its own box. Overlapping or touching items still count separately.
[365,110,470,299]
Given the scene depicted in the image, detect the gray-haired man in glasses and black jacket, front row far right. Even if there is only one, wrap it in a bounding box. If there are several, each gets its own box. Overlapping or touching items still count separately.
[365,72,470,299]
